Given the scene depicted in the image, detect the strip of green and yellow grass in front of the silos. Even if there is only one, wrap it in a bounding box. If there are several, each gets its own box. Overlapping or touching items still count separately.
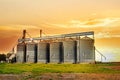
[0,63,120,74]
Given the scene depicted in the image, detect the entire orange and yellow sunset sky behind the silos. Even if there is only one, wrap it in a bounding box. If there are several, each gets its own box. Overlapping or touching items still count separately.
[0,0,120,61]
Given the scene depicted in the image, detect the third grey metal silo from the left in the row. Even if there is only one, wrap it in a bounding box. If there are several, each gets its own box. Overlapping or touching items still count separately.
[37,42,49,63]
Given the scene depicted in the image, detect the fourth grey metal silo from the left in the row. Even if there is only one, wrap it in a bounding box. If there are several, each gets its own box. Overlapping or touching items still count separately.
[50,42,63,63]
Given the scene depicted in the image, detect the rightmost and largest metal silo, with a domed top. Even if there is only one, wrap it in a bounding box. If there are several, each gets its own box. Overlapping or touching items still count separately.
[80,37,95,63]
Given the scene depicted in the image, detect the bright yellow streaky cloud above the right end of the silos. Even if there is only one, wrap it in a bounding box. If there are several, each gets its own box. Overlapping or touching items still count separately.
[47,18,120,28]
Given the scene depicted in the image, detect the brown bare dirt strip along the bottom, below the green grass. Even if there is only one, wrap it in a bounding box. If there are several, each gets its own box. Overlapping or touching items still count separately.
[0,73,120,80]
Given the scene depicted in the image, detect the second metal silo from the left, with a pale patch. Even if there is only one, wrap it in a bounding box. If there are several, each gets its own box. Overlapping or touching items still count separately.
[26,43,37,63]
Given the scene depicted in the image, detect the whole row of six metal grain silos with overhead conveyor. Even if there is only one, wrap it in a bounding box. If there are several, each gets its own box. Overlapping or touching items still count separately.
[16,30,95,63]
